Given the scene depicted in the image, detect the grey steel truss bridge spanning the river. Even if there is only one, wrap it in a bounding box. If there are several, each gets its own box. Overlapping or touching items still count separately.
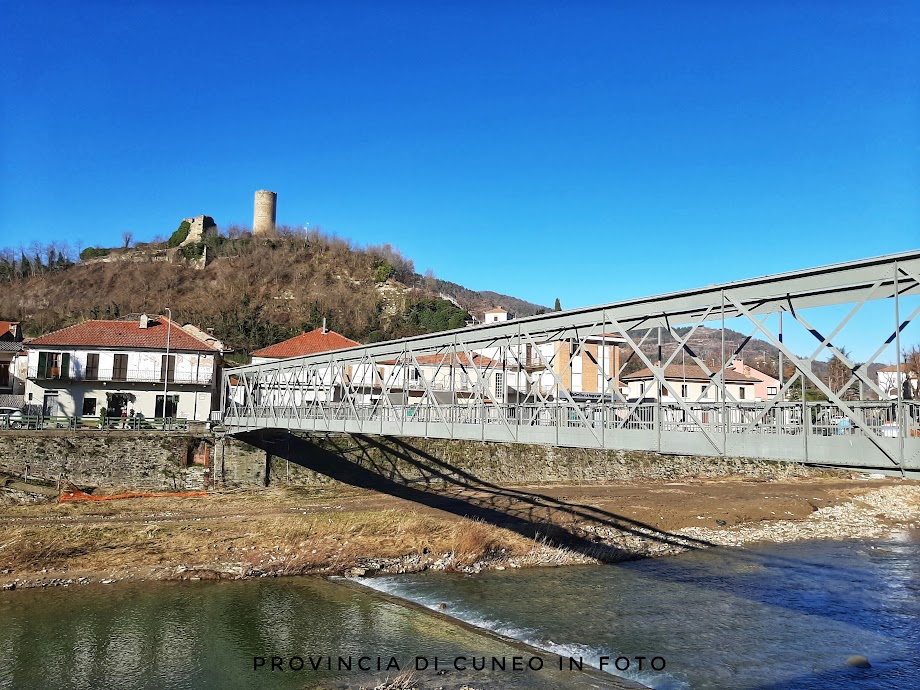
[221,251,920,476]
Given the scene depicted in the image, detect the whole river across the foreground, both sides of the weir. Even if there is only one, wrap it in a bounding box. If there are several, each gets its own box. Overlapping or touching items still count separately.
[0,534,920,690]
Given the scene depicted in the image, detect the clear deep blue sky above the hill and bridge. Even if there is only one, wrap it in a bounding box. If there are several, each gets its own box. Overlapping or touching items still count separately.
[0,0,920,360]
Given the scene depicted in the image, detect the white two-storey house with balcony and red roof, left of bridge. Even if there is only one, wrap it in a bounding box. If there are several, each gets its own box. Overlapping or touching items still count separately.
[25,314,222,421]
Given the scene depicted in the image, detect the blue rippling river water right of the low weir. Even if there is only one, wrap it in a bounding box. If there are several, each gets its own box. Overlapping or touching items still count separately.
[365,534,920,690]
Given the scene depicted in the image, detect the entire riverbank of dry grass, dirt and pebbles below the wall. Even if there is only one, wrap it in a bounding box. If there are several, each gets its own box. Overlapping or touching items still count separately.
[0,474,920,589]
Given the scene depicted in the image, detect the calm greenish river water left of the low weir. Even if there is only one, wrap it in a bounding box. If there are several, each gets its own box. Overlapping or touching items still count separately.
[0,578,620,690]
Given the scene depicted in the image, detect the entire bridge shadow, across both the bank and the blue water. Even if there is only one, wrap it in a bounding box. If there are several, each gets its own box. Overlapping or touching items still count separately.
[239,429,904,627]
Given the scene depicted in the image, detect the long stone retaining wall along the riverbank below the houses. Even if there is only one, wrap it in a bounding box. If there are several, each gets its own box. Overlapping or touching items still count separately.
[0,431,827,491]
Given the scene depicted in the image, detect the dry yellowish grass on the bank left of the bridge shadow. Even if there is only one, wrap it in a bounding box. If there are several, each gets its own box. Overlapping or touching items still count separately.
[0,491,530,579]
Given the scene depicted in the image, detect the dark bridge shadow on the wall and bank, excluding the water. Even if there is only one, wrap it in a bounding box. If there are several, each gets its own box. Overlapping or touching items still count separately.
[239,430,714,563]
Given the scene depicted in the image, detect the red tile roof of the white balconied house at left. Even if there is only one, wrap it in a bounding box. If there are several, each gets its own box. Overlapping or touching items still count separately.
[29,316,219,352]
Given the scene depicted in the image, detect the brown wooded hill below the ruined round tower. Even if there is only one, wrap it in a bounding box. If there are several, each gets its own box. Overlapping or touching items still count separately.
[0,227,545,353]
